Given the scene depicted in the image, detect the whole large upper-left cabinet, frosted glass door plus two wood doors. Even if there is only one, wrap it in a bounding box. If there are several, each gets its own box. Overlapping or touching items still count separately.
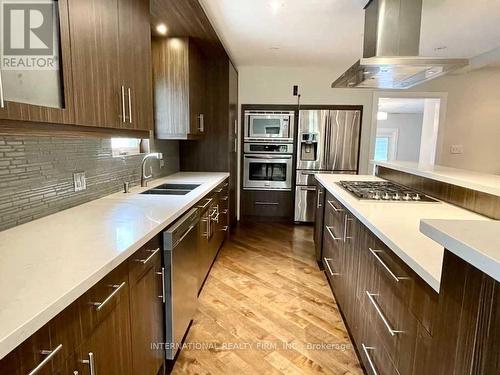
[0,0,153,130]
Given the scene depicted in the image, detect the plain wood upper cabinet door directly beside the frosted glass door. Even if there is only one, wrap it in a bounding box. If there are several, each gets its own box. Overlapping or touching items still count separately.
[68,0,121,127]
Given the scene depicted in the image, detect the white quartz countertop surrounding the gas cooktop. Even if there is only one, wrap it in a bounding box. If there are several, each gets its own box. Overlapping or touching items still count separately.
[315,174,490,292]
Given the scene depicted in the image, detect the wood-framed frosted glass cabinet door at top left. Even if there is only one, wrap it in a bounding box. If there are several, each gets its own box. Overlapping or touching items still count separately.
[0,0,71,122]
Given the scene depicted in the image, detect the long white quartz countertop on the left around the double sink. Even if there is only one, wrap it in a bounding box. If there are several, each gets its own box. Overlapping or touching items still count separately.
[0,172,229,359]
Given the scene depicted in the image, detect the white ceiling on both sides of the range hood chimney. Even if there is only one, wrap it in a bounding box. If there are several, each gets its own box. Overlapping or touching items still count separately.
[200,0,500,70]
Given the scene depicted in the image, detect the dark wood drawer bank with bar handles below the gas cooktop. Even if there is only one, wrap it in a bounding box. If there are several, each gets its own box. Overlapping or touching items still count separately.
[322,192,437,375]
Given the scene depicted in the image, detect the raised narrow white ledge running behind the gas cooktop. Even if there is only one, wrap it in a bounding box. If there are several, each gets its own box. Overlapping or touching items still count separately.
[374,161,500,196]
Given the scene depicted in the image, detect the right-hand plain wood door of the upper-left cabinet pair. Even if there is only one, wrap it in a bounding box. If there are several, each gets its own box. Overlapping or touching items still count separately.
[118,0,153,130]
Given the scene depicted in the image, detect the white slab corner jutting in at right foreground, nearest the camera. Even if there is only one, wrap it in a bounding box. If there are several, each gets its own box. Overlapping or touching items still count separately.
[420,220,500,282]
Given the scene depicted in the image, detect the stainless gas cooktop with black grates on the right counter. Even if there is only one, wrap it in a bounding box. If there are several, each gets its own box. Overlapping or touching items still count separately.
[339,181,438,202]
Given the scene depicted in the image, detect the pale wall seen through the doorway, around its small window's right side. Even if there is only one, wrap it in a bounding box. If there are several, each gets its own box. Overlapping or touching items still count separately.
[377,113,423,162]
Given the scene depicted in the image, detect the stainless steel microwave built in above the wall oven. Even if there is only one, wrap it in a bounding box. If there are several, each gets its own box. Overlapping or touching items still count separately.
[245,111,295,142]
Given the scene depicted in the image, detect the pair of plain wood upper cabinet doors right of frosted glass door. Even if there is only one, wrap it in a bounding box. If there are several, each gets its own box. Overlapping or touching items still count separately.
[68,0,153,130]
